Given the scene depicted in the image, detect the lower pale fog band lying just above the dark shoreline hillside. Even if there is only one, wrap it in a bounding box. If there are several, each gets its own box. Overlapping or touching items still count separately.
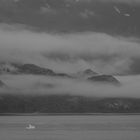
[0,75,140,98]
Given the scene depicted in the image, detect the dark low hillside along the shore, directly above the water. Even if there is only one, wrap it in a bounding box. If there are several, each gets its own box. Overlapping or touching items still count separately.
[0,94,140,113]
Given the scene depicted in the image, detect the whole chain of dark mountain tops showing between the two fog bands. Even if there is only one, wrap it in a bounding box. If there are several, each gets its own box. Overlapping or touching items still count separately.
[0,63,120,85]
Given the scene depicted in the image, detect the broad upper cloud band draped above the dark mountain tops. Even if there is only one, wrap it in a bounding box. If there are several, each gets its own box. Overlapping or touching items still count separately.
[0,25,140,74]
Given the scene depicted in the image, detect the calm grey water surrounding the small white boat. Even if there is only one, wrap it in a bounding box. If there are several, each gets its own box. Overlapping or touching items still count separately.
[0,115,140,140]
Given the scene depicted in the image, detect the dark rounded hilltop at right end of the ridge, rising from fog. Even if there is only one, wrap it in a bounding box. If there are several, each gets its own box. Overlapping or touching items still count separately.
[88,75,120,85]
